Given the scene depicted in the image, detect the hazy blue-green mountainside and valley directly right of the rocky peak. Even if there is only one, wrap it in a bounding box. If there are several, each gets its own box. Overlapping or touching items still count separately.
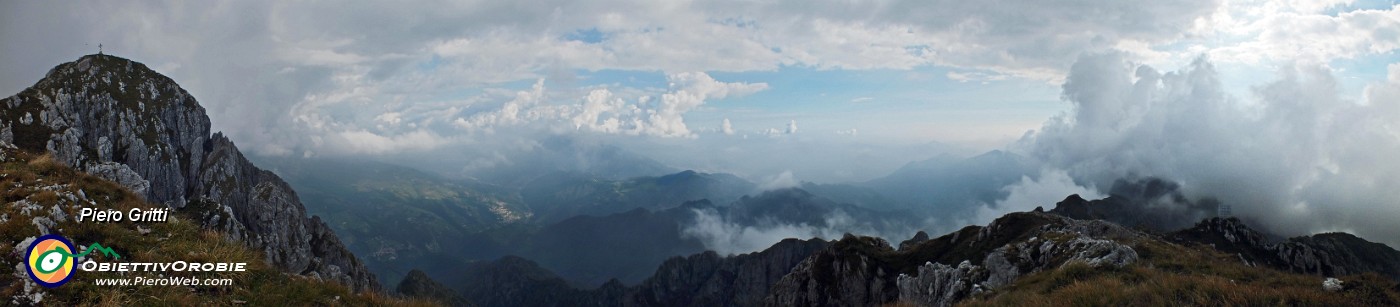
[256,157,533,285]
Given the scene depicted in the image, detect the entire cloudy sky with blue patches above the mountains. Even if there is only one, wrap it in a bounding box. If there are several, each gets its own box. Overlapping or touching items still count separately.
[8,0,1400,242]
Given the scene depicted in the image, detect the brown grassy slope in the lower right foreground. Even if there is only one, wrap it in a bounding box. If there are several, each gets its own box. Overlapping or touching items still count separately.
[962,240,1400,306]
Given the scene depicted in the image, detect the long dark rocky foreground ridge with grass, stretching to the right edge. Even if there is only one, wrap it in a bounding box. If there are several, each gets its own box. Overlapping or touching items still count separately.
[420,195,1400,306]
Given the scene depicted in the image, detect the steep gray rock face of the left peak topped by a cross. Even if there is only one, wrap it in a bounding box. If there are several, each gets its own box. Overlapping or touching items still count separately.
[0,55,379,290]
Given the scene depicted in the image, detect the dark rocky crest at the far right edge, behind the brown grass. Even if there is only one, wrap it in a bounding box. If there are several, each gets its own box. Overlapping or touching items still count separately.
[1169,217,1400,279]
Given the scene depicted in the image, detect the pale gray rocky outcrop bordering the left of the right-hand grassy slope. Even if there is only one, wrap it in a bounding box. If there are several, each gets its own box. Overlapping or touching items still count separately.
[764,212,1144,306]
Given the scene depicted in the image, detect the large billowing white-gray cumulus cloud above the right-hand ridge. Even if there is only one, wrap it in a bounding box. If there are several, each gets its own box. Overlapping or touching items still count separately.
[1019,53,1400,244]
